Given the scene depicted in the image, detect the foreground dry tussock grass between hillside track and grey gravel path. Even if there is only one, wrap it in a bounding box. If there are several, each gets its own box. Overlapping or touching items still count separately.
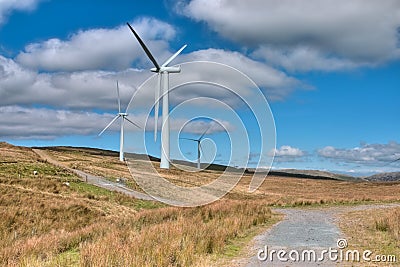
[0,144,273,266]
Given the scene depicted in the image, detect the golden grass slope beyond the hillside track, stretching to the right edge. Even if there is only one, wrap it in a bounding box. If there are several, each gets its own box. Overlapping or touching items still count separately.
[39,148,400,206]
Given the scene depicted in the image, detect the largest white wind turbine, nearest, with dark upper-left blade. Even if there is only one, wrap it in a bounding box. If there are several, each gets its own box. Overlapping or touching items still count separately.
[127,23,186,169]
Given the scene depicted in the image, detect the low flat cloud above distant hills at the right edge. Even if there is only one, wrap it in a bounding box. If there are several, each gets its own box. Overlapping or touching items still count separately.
[318,141,400,164]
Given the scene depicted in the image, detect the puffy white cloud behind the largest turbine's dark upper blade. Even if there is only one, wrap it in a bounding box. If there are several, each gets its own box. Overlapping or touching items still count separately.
[16,18,175,71]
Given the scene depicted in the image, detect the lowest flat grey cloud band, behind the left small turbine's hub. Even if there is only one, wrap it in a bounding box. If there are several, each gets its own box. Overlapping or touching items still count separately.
[0,106,233,139]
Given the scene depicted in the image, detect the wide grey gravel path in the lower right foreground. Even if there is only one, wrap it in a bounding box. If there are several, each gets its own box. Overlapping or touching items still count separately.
[239,203,400,267]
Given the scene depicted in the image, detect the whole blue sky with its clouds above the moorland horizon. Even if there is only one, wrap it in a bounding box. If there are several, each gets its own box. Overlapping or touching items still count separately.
[0,0,400,175]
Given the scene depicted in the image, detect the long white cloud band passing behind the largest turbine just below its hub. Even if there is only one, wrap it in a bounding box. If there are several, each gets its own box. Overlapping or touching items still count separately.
[0,46,303,110]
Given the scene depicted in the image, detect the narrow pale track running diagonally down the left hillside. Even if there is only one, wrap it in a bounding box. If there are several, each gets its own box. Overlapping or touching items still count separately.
[33,149,154,200]
